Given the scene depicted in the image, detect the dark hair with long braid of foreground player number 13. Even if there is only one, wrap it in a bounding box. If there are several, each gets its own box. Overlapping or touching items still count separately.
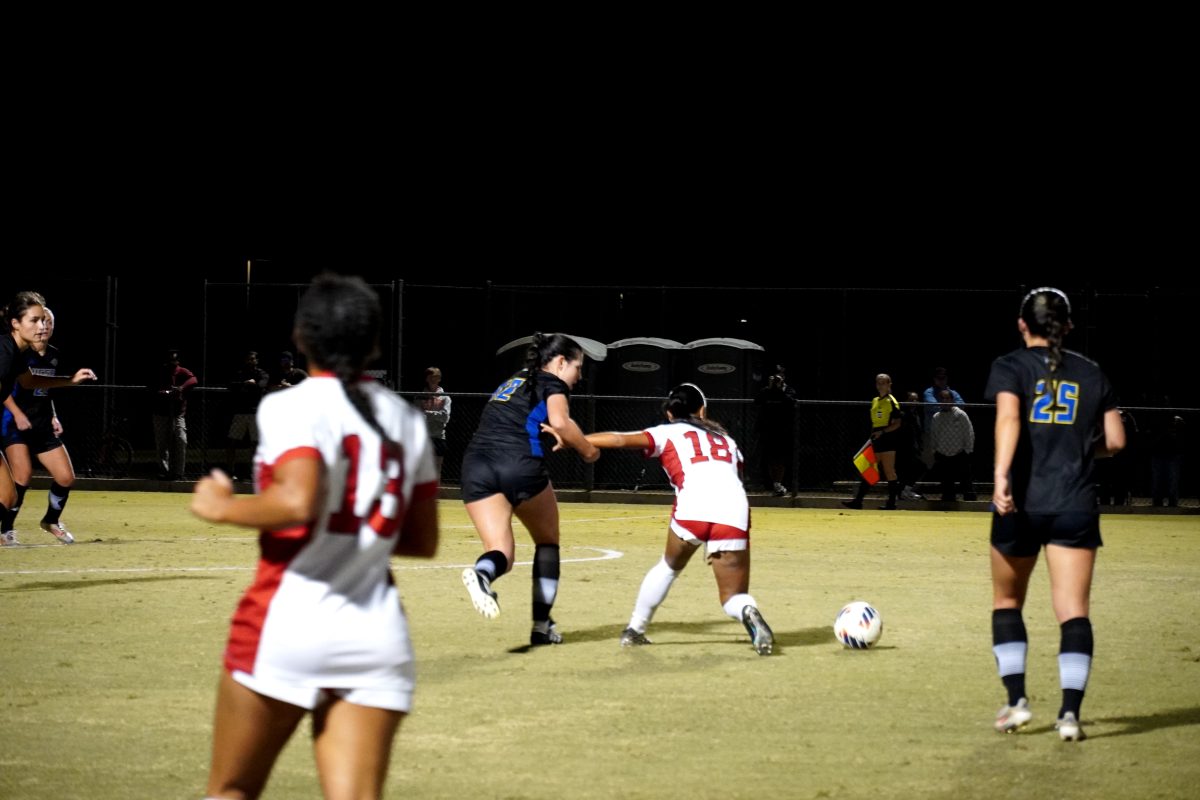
[295,272,392,446]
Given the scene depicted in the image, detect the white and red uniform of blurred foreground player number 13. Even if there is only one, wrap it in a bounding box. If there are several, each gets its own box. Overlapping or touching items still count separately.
[224,377,437,711]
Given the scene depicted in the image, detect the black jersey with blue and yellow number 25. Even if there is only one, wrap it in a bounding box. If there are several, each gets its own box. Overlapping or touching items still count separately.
[985,347,1117,513]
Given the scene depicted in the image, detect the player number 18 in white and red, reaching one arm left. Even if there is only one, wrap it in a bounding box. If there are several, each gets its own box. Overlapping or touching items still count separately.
[588,384,774,656]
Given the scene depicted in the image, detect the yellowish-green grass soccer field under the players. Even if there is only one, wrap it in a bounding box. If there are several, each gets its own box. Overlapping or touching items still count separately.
[0,492,1200,800]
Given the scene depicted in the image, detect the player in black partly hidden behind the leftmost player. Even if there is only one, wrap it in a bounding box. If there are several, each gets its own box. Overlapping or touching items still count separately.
[0,308,81,545]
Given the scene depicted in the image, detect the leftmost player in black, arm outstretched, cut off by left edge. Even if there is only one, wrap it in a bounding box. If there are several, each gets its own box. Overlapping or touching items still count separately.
[0,291,96,545]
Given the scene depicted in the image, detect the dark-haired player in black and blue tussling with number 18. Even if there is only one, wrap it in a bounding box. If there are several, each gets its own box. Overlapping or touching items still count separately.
[462,333,600,644]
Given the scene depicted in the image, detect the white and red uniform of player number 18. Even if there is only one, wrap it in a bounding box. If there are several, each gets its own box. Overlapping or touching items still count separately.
[644,422,750,553]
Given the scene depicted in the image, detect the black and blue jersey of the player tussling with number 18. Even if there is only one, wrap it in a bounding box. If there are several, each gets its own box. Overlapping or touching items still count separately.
[468,369,571,458]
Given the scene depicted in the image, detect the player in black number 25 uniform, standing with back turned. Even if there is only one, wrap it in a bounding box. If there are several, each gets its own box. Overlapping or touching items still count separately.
[986,287,1124,741]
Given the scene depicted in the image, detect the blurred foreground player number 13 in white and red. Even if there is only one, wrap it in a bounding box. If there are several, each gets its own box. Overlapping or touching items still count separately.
[184,276,437,798]
